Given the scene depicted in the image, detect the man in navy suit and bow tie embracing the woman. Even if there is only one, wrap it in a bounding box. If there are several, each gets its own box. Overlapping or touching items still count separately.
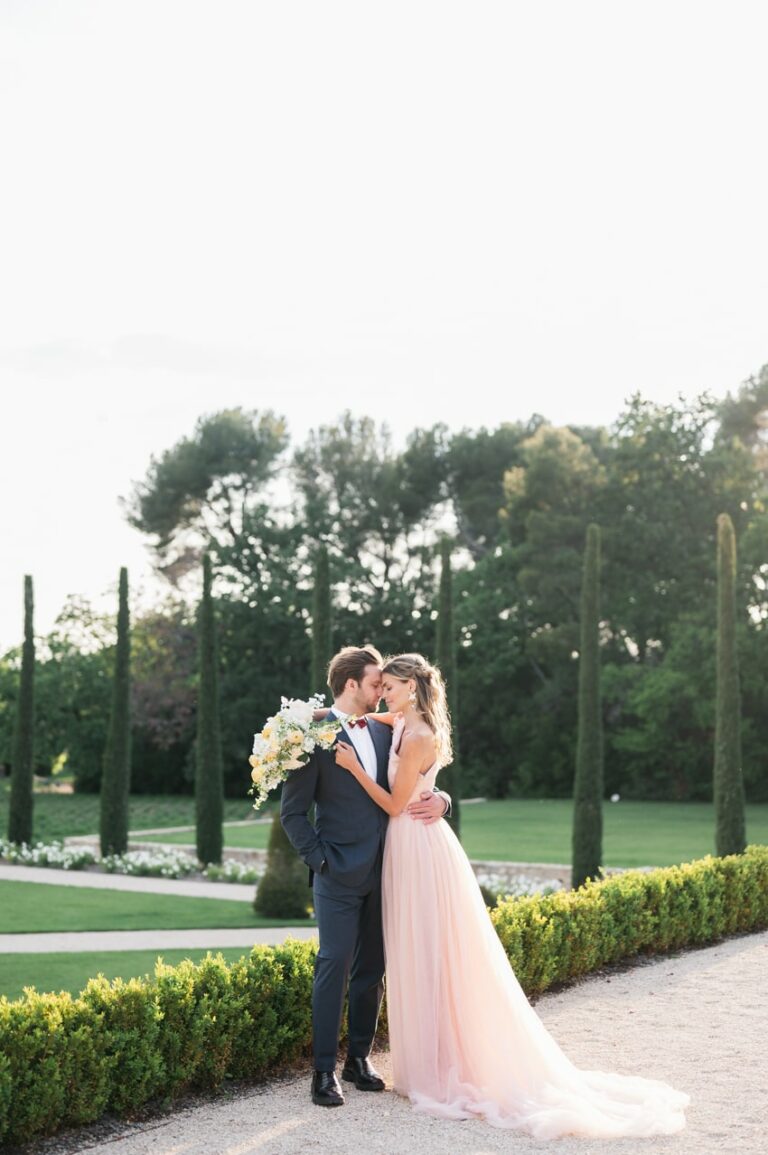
[281,646,450,1106]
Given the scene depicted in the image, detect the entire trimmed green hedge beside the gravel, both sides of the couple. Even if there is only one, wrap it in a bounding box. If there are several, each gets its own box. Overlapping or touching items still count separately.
[0,847,768,1143]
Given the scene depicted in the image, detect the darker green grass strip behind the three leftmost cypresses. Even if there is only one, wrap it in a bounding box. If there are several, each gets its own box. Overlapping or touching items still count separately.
[0,781,252,842]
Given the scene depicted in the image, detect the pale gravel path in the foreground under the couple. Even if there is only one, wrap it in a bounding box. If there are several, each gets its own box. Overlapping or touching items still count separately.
[19,932,768,1155]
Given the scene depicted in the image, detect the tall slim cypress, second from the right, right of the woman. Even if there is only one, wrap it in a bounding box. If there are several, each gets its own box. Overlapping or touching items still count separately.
[571,526,603,888]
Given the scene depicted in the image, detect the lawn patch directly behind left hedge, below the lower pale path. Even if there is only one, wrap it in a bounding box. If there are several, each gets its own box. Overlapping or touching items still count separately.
[0,946,257,999]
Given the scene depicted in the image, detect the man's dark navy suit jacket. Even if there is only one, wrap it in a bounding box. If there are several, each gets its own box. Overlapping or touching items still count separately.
[279,711,392,886]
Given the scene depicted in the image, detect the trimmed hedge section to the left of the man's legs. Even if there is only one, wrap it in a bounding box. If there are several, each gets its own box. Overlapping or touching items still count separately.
[0,941,314,1143]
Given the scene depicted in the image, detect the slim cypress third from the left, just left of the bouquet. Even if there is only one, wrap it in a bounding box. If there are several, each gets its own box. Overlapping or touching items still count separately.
[195,554,224,864]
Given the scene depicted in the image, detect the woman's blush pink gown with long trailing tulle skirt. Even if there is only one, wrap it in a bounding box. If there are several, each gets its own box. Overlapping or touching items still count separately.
[382,722,688,1139]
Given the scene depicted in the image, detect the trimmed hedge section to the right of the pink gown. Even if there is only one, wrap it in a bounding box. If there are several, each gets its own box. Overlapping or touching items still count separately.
[491,845,768,996]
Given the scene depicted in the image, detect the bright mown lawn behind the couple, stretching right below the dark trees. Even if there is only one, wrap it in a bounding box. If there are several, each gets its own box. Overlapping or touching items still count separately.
[138,798,768,866]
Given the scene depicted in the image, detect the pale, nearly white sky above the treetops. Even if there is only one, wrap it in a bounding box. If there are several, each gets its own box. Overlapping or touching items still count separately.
[0,0,768,650]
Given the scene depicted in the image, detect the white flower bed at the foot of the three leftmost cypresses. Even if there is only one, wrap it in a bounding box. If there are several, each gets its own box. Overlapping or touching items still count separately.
[0,839,260,884]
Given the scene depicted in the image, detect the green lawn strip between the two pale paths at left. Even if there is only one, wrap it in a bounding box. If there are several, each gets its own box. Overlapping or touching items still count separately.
[0,881,311,934]
